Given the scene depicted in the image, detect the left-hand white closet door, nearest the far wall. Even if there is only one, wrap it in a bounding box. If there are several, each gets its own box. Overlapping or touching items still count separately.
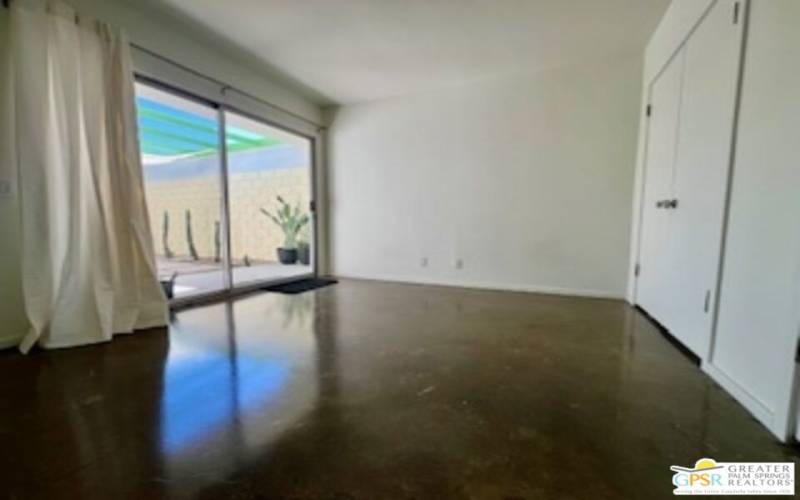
[636,50,684,328]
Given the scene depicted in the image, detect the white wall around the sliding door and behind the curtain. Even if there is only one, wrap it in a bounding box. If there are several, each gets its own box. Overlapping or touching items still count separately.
[0,0,324,348]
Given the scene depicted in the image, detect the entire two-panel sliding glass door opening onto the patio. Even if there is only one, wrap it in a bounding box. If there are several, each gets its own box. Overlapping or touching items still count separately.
[136,82,314,300]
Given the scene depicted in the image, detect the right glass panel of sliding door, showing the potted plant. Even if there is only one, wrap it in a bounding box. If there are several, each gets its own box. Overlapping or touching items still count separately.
[225,111,314,286]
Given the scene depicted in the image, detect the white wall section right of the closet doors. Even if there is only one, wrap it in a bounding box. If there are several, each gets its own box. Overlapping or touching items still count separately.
[708,0,800,438]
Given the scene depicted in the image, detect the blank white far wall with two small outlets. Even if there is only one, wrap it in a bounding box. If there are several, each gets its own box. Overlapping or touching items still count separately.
[329,56,642,297]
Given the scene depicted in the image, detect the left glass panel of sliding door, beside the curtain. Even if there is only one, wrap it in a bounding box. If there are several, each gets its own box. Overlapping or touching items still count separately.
[136,82,227,298]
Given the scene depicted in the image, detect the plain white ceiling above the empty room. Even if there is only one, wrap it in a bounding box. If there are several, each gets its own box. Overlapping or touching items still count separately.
[139,0,669,105]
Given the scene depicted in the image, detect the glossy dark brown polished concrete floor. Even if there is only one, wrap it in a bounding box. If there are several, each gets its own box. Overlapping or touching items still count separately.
[0,281,798,500]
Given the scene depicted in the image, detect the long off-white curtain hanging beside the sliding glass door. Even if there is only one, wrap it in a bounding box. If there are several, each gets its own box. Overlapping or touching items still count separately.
[10,0,167,352]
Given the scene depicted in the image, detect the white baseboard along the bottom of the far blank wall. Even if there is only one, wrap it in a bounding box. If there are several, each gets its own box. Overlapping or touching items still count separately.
[333,273,625,300]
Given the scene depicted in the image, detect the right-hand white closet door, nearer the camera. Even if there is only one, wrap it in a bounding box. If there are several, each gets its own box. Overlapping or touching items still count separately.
[664,0,742,358]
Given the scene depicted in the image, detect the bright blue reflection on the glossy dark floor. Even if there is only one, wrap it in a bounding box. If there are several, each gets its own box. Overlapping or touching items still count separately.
[161,346,289,454]
